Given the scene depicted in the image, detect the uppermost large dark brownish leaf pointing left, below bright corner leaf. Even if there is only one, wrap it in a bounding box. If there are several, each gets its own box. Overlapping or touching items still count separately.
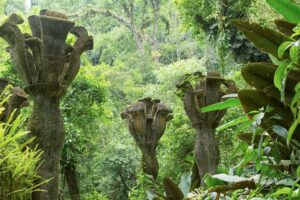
[232,20,290,58]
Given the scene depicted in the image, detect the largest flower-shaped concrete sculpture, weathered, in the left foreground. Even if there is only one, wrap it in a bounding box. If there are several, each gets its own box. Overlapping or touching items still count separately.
[0,10,93,200]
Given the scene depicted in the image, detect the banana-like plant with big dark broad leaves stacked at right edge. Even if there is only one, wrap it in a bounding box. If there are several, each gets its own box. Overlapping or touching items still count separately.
[232,0,300,158]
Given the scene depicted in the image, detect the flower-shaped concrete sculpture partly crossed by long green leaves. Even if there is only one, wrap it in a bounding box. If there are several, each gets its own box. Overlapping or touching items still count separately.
[177,72,237,184]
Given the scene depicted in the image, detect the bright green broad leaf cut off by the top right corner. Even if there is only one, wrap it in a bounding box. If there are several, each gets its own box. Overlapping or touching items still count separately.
[267,0,300,23]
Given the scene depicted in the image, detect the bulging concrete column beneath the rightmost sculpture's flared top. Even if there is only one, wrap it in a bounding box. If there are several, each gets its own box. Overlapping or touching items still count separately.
[195,123,220,185]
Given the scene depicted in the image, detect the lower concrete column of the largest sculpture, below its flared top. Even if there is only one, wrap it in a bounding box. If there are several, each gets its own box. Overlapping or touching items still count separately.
[29,94,64,200]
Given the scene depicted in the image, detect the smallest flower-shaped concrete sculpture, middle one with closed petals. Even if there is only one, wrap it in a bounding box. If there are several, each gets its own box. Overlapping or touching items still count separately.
[121,98,172,178]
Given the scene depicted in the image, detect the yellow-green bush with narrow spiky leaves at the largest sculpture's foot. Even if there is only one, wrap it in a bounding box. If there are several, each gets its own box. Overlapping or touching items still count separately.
[0,92,46,200]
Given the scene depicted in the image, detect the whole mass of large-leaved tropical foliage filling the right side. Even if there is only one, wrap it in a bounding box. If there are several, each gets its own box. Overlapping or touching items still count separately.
[185,0,300,199]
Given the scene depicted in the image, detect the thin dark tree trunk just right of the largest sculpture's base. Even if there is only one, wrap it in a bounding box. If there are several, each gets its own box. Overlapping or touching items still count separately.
[64,163,80,200]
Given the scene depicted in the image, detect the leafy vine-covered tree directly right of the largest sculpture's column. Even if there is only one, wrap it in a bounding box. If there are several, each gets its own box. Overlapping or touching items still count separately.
[61,64,106,200]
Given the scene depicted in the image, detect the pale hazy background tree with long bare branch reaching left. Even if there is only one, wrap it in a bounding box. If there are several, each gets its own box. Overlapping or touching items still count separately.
[69,0,170,61]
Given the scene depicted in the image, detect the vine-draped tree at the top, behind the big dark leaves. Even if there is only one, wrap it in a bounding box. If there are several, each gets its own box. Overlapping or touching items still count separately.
[176,0,269,74]
